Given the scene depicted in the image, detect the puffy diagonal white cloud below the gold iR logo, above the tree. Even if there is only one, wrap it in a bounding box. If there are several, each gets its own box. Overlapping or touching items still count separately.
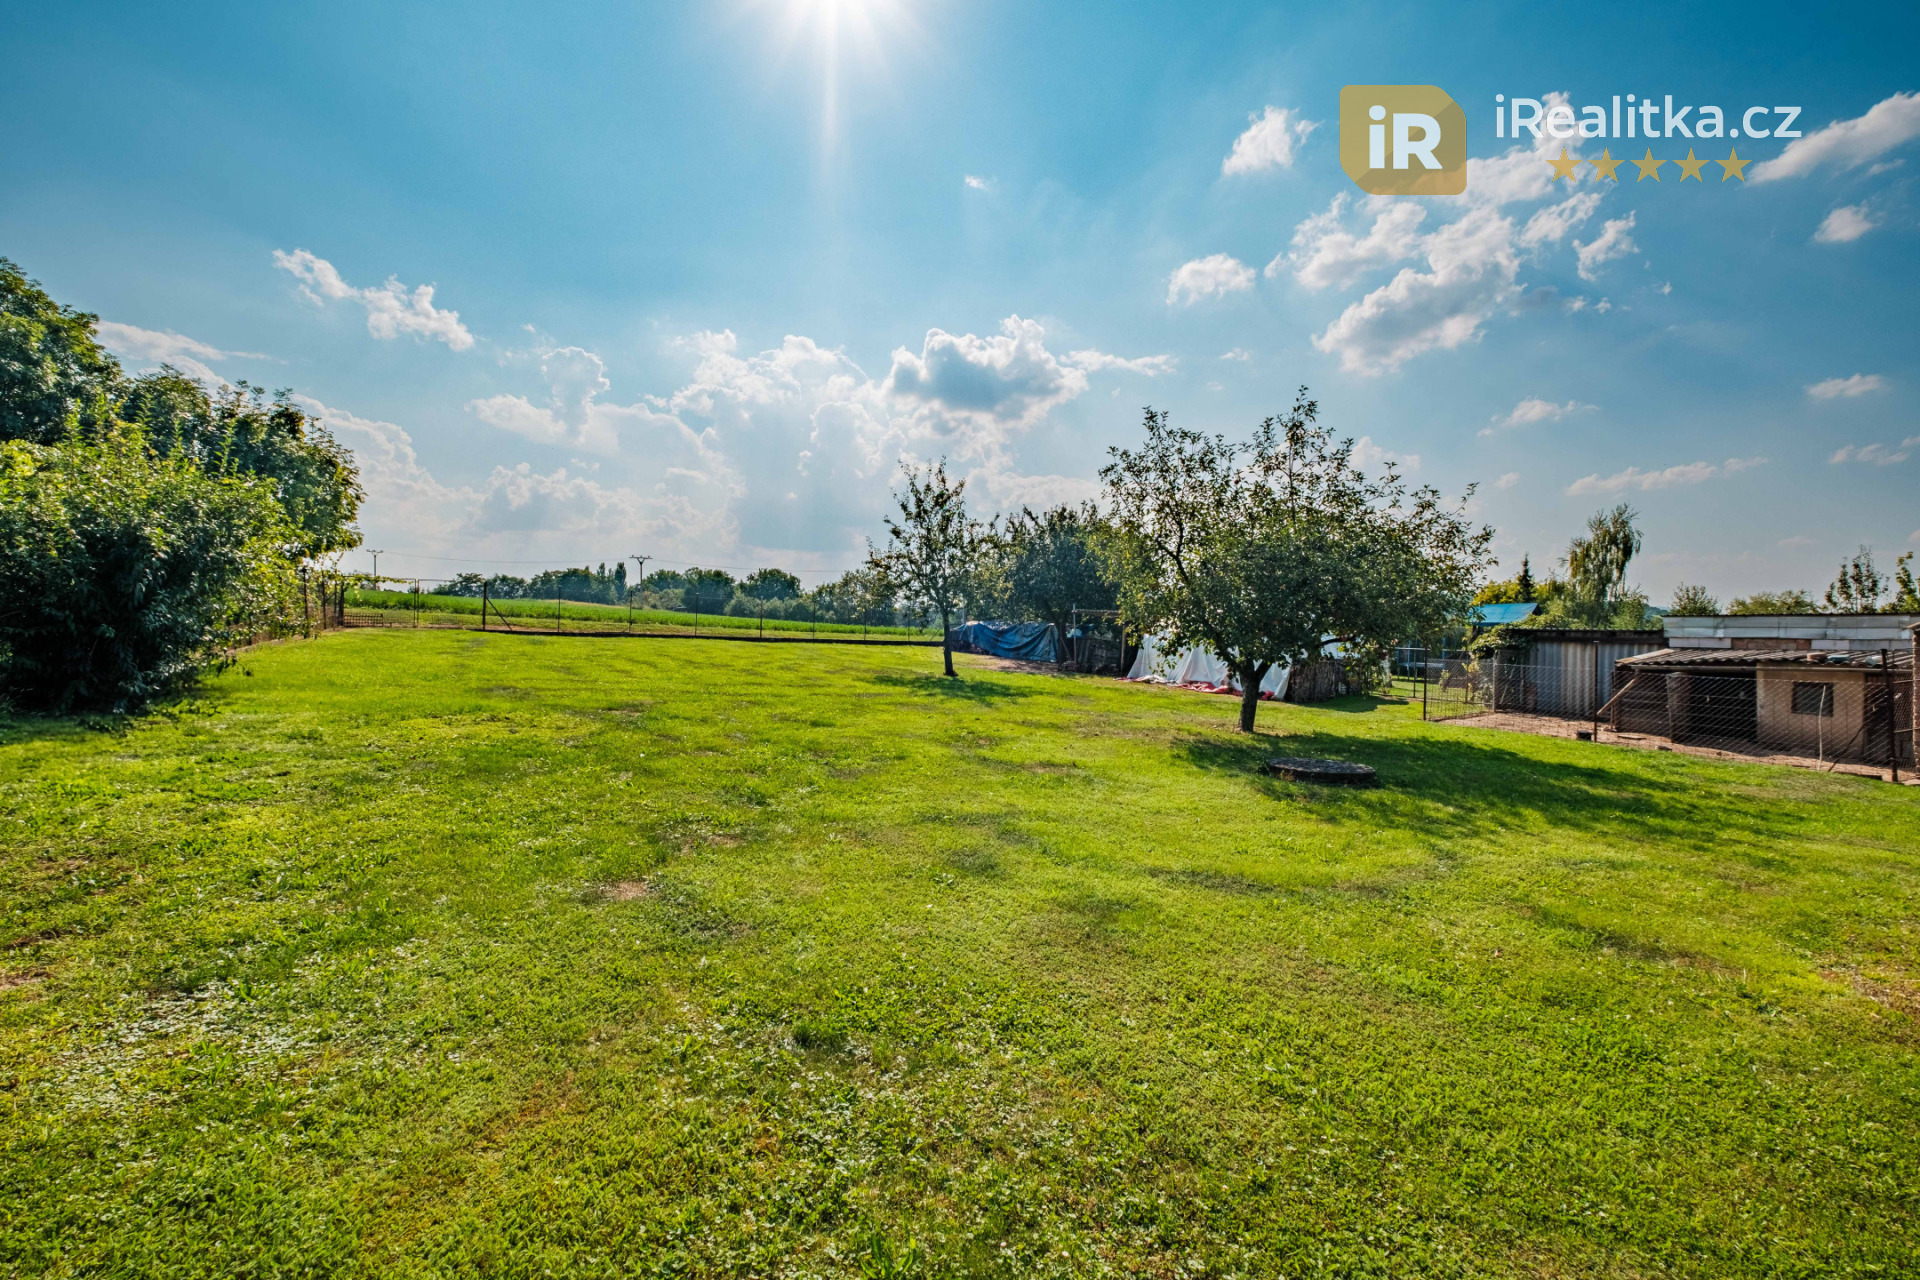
[1313,207,1521,376]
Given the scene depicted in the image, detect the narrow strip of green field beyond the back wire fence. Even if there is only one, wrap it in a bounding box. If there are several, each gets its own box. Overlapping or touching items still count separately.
[346,589,941,639]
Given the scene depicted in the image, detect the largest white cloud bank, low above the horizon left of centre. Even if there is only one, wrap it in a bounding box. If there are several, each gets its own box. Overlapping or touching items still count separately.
[309,317,1173,572]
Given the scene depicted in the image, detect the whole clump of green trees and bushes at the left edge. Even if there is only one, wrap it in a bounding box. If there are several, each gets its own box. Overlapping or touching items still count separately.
[0,249,363,712]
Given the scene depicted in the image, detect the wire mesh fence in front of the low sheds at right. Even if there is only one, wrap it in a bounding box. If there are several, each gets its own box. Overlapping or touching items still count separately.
[1392,649,1914,775]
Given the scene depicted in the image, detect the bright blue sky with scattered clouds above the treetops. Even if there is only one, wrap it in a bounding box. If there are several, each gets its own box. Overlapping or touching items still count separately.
[0,0,1920,601]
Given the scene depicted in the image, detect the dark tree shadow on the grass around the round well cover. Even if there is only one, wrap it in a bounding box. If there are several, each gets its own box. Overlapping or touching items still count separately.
[1173,731,1805,852]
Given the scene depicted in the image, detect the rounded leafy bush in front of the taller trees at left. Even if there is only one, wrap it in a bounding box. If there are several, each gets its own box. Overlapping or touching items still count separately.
[0,432,303,712]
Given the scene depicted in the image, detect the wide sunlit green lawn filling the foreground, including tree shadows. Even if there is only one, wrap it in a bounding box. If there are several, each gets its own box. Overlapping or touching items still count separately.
[0,631,1920,1276]
